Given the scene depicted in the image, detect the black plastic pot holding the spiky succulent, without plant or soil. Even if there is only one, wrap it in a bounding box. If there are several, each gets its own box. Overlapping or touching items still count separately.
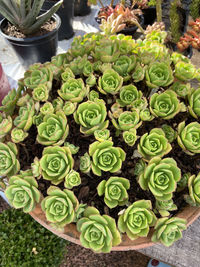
[0,15,61,69]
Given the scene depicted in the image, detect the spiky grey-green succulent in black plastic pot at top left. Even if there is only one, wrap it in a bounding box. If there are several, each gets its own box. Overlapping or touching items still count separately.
[0,0,63,68]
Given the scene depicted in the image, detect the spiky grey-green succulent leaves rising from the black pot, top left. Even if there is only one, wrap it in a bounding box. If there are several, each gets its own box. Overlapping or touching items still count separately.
[0,0,63,35]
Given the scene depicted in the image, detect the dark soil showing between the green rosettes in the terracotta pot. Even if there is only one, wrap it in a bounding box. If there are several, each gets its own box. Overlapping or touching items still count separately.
[18,69,200,220]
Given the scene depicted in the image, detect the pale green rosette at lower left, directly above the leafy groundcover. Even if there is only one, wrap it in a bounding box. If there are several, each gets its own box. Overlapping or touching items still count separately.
[5,171,40,213]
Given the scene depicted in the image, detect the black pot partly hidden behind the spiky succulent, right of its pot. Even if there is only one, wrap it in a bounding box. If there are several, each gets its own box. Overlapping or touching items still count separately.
[42,0,74,41]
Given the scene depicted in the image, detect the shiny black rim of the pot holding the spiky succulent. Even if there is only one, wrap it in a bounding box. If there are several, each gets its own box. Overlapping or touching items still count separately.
[0,10,61,43]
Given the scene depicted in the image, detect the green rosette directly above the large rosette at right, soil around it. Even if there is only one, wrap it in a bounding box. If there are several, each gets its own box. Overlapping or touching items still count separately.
[138,128,172,161]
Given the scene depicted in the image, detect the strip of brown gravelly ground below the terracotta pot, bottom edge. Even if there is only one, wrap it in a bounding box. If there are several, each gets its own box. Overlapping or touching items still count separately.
[60,243,150,267]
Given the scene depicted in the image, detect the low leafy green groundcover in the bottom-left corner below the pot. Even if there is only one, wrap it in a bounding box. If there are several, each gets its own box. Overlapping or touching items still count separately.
[0,209,67,267]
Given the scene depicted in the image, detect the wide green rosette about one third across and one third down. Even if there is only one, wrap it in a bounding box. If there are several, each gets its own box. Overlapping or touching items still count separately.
[58,78,88,103]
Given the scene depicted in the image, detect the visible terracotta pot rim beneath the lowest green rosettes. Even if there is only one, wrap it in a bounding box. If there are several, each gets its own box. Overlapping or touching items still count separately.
[30,205,200,251]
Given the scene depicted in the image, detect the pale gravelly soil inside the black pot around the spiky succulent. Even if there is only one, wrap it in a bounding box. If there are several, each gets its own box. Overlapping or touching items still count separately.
[4,19,56,38]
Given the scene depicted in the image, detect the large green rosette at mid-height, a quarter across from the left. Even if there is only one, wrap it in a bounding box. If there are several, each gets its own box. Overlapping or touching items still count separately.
[37,110,69,146]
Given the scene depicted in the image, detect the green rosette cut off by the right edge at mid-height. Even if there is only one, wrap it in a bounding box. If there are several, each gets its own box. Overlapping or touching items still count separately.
[177,121,200,156]
